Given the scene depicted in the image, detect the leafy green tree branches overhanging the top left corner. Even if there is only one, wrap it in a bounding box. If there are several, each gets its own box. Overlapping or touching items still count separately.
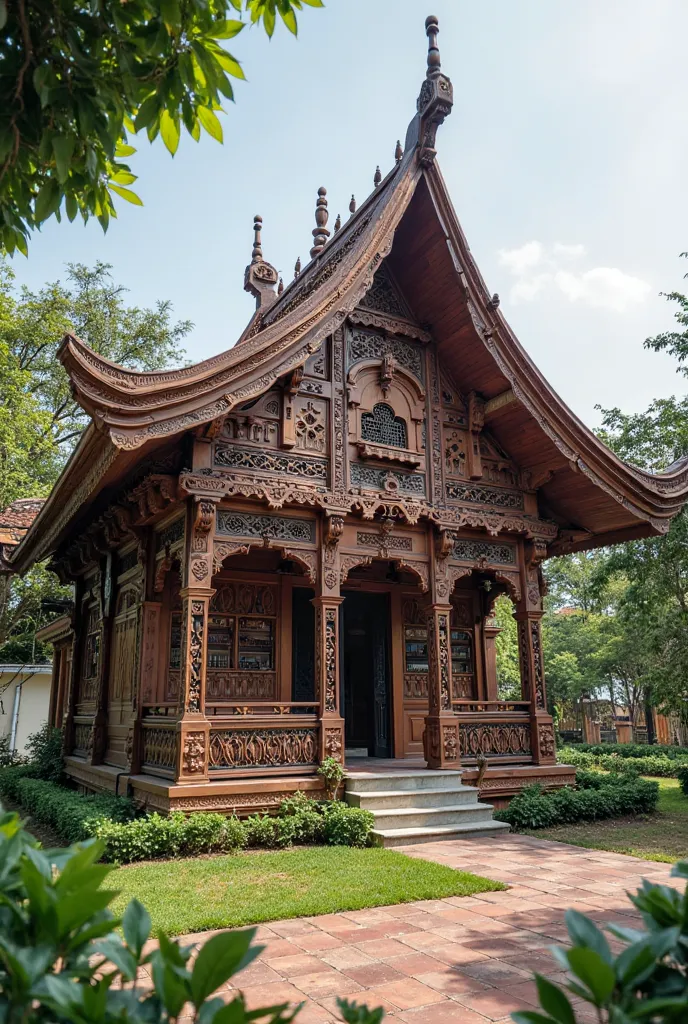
[0,0,323,255]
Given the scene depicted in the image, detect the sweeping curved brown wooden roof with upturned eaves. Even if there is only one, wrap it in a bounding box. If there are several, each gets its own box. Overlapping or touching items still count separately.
[9,22,688,569]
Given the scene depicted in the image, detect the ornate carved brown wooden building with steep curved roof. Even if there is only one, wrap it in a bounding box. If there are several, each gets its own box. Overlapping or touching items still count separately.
[11,18,688,810]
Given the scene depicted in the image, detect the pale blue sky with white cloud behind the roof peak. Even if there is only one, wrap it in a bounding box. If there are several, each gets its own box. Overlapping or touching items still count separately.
[9,0,688,425]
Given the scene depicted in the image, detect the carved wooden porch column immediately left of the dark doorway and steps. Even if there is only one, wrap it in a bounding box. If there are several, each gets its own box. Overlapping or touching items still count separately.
[313,515,344,764]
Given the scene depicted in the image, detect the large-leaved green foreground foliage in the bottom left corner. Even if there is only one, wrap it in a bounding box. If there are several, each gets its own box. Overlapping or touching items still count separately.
[0,808,382,1024]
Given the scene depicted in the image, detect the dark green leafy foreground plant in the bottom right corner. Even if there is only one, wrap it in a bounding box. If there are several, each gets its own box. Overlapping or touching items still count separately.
[511,861,688,1024]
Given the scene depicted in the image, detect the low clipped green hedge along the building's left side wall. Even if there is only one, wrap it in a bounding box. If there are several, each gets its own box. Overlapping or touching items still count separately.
[14,778,134,843]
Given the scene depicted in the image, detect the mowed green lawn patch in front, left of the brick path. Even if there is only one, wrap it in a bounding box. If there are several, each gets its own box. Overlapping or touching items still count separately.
[106,847,507,935]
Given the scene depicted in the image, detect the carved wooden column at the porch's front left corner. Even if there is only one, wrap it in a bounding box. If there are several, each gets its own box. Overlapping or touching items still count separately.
[175,497,216,784]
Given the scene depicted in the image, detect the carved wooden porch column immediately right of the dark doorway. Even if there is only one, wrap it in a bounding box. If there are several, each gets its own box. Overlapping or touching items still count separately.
[423,536,461,768]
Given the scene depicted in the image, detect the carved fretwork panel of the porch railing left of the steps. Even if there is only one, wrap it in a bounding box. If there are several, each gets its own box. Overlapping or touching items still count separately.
[210,729,317,769]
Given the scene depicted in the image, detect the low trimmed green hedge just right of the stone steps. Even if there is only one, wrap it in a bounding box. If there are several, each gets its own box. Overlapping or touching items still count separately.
[495,769,659,830]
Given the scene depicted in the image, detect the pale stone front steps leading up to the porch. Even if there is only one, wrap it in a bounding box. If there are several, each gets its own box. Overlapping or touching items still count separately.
[344,768,509,846]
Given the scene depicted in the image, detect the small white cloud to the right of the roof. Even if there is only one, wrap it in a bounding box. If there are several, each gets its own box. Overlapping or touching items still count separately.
[499,241,650,312]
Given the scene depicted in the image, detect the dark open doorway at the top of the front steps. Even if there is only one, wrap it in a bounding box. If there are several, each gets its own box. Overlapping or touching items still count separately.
[340,591,392,758]
